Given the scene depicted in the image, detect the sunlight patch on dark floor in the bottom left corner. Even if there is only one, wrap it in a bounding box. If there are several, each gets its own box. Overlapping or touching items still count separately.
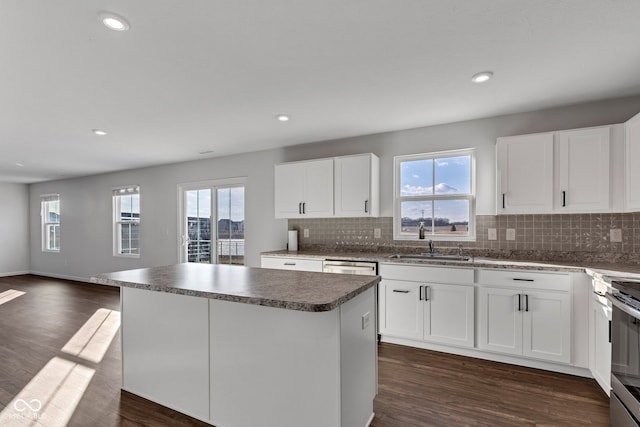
[0,357,95,427]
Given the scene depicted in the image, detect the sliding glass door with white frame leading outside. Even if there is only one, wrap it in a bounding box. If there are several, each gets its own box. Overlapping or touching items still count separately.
[180,181,245,265]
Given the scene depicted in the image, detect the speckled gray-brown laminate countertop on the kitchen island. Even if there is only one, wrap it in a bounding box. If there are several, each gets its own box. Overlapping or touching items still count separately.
[91,263,380,312]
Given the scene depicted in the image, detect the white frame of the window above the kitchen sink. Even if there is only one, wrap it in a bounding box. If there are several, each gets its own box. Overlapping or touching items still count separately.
[393,148,476,242]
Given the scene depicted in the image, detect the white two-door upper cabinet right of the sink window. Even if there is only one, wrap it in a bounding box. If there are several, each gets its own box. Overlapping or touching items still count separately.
[496,126,612,214]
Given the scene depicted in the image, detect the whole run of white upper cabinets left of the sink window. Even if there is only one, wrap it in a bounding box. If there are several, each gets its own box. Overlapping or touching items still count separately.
[275,153,380,218]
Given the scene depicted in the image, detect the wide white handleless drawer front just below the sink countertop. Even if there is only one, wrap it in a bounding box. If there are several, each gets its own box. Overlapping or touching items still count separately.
[379,264,473,285]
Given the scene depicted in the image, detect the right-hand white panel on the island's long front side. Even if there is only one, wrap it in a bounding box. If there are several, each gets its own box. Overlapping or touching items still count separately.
[210,300,340,427]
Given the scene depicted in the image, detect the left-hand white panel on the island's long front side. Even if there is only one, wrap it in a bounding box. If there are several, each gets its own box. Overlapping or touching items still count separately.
[121,287,209,421]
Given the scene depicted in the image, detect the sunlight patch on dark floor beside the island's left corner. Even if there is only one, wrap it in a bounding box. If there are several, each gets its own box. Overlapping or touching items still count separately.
[62,308,120,363]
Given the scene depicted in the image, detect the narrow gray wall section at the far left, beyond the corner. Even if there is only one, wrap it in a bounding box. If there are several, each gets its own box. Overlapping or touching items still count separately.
[0,183,29,276]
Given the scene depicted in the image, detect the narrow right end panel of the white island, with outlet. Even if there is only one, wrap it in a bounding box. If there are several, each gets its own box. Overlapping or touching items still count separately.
[340,287,378,427]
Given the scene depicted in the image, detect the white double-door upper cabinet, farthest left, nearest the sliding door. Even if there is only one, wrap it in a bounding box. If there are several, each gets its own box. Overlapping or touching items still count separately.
[275,159,333,218]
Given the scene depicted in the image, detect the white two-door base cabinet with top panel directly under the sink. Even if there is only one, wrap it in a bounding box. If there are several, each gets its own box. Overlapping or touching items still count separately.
[379,266,474,347]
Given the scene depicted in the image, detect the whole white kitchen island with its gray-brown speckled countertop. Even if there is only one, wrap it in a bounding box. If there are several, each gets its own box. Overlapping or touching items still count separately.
[91,264,380,427]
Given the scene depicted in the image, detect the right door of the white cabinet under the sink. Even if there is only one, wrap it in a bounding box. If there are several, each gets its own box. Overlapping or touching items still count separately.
[424,284,474,347]
